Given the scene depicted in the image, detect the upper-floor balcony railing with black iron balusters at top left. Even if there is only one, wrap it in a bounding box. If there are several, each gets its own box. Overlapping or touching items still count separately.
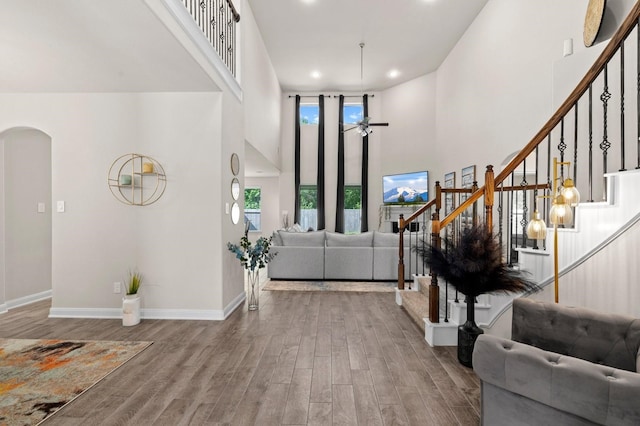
[182,0,240,77]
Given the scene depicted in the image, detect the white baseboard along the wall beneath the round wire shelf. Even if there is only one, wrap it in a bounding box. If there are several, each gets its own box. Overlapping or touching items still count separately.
[49,292,246,321]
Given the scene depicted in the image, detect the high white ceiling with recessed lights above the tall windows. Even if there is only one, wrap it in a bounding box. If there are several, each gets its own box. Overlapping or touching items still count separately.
[248,0,488,91]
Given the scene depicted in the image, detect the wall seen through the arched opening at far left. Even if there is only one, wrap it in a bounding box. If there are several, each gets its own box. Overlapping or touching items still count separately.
[0,129,52,302]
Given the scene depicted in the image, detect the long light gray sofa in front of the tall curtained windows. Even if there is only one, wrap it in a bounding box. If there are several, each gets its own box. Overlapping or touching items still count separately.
[268,230,415,281]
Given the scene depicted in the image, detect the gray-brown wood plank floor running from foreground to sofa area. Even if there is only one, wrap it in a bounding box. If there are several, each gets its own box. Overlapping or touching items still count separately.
[0,291,480,426]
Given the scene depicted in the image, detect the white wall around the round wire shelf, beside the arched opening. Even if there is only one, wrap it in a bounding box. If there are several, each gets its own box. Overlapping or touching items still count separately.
[0,93,242,316]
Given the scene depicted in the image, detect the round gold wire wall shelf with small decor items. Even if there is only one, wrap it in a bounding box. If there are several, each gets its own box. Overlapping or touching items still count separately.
[107,153,167,206]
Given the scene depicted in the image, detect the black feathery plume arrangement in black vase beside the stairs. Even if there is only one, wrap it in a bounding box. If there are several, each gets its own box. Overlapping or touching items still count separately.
[414,224,539,367]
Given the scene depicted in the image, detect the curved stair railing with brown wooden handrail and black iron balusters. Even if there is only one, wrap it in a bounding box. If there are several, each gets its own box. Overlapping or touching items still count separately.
[398,2,640,323]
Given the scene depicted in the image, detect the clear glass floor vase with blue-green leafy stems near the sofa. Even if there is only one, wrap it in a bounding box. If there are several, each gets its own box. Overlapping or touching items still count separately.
[227,226,275,311]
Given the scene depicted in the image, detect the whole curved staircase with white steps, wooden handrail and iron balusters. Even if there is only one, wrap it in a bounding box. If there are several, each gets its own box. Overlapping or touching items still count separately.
[396,3,640,346]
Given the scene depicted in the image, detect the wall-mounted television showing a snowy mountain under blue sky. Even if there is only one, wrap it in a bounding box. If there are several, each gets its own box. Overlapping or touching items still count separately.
[382,171,429,204]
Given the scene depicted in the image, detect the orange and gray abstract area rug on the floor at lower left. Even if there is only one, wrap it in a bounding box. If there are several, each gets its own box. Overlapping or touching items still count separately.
[0,339,151,425]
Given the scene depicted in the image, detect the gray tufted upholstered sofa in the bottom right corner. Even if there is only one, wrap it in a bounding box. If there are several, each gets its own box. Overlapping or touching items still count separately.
[473,299,640,426]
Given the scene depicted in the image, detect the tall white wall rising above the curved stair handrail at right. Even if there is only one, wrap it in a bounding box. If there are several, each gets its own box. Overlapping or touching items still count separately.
[436,0,586,184]
